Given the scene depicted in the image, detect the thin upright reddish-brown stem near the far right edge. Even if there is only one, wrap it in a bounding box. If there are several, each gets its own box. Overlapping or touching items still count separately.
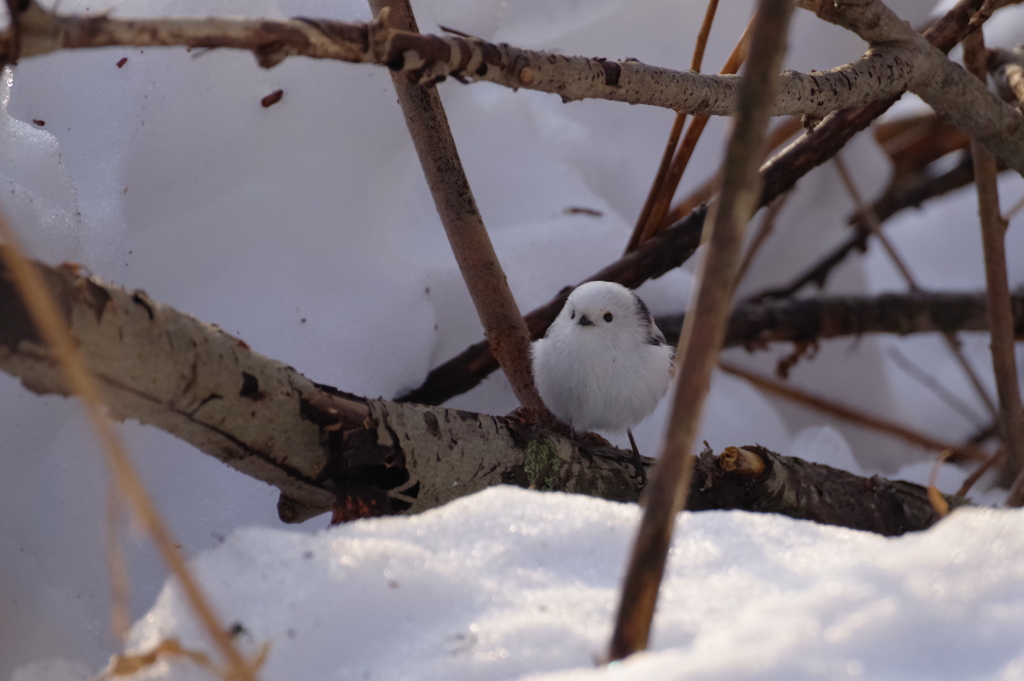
[964,29,1024,506]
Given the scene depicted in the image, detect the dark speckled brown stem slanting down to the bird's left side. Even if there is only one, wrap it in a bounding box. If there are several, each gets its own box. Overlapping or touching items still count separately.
[370,0,545,409]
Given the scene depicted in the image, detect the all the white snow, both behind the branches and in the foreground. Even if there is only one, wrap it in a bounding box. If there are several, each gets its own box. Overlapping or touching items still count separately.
[6,0,1024,681]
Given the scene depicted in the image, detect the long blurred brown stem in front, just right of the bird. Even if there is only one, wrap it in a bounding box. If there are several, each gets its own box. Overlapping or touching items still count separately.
[609,0,793,659]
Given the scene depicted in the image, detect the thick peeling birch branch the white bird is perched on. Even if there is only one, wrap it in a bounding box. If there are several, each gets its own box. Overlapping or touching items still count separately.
[0,247,963,534]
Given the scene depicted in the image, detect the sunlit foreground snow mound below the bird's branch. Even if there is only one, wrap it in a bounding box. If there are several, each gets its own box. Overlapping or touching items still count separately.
[12,487,1024,681]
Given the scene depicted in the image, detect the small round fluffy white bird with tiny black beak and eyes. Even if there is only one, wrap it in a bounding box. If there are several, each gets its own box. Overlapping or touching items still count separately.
[531,282,675,446]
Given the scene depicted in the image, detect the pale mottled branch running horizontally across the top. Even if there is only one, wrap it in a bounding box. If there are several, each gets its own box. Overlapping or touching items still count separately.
[0,0,1024,172]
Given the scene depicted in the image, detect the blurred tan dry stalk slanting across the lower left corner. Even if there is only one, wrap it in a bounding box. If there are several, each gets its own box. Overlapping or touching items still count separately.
[0,217,256,681]
